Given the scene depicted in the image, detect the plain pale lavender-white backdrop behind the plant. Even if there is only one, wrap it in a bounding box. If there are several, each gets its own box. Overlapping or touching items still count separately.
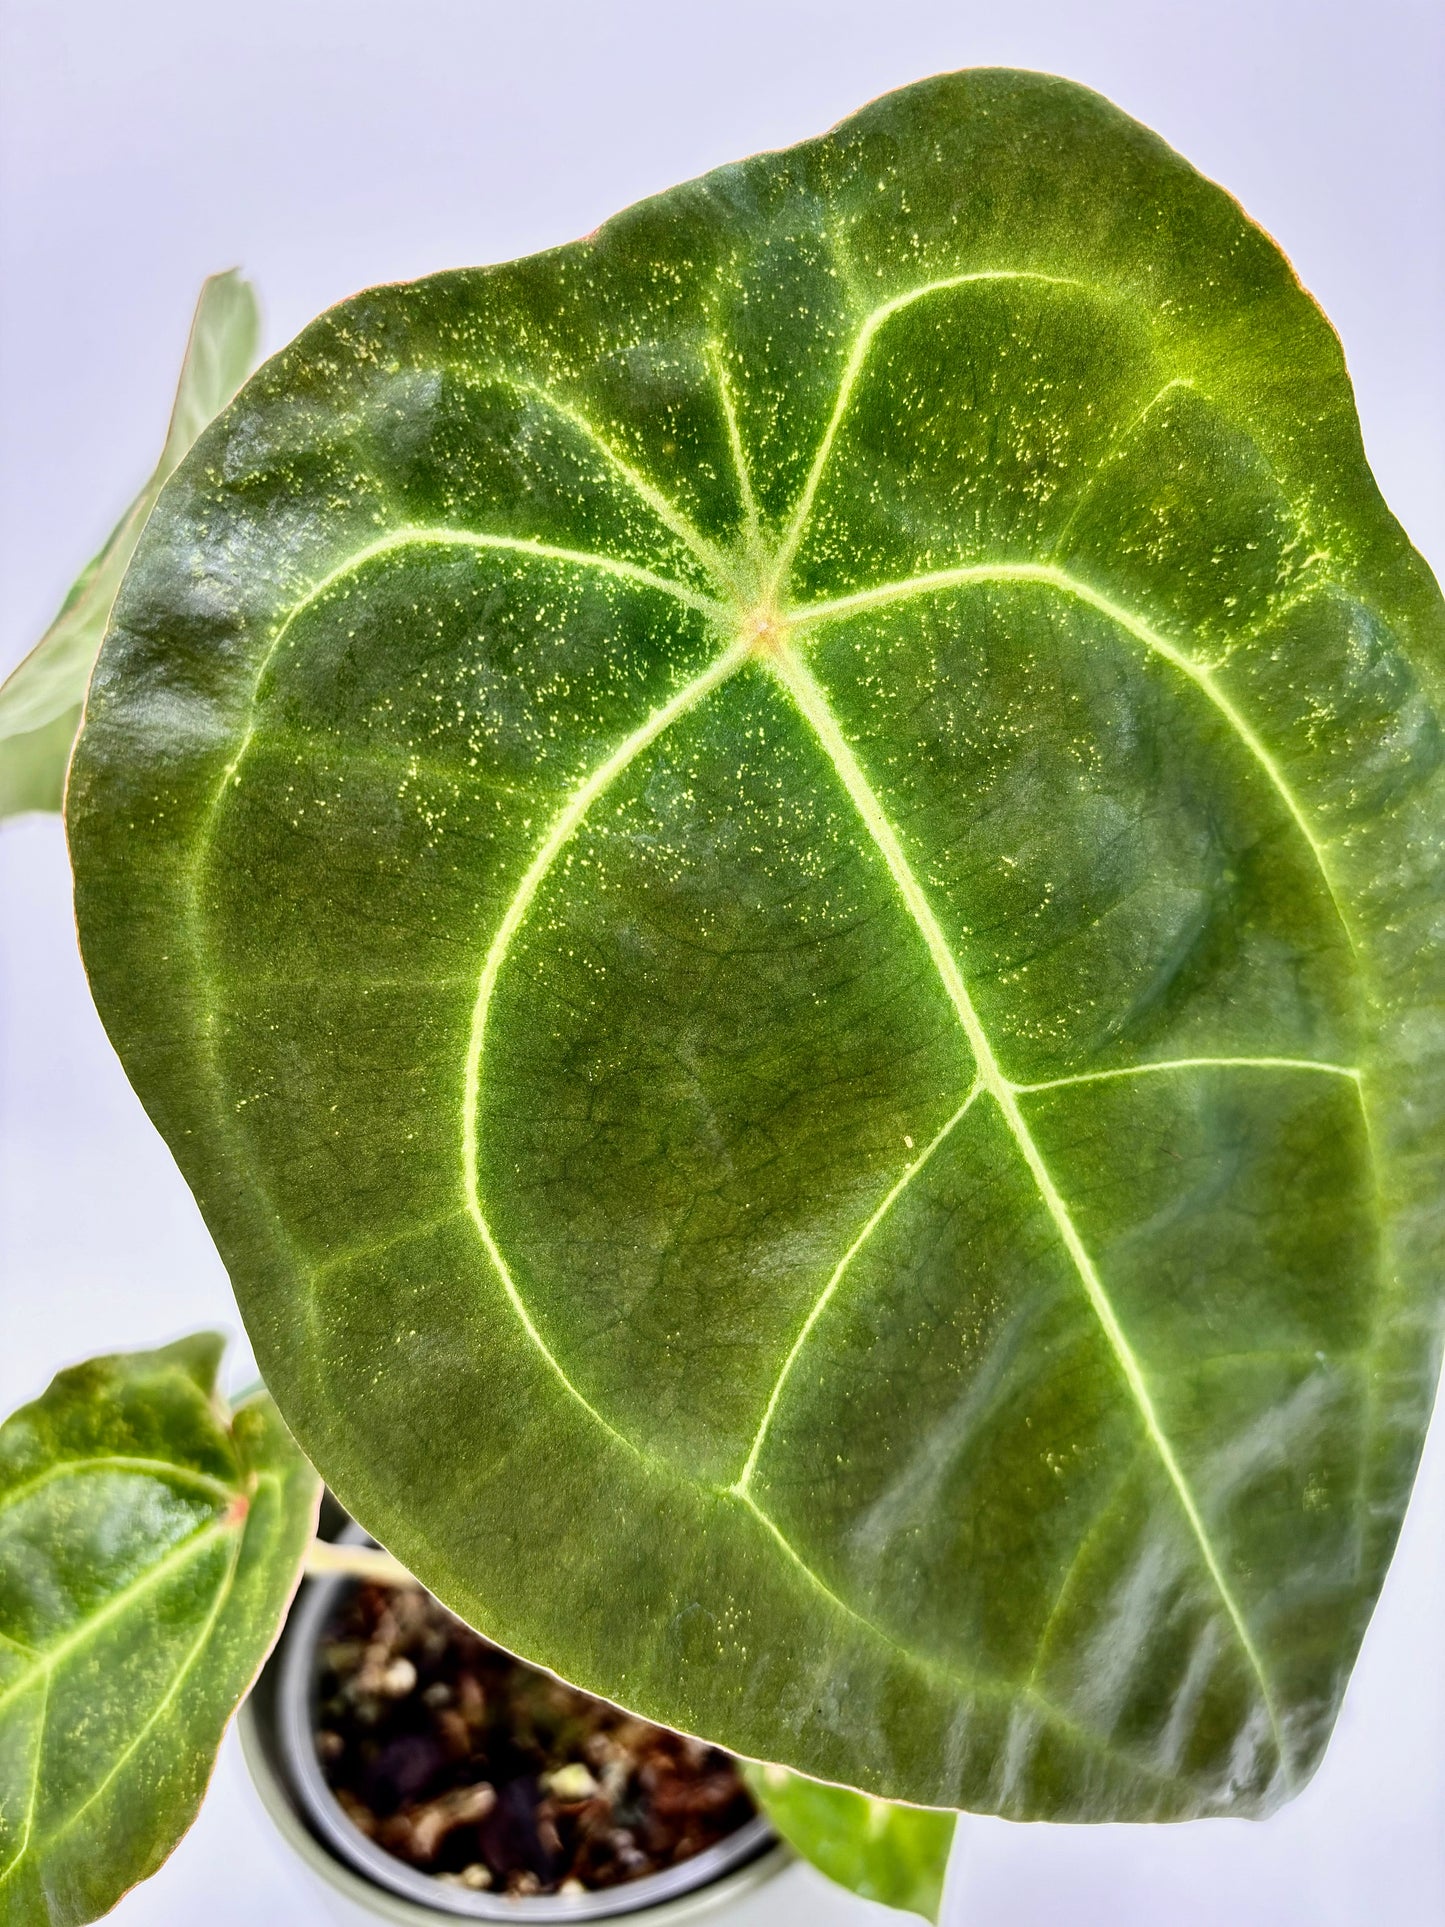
[0,0,1445,1927]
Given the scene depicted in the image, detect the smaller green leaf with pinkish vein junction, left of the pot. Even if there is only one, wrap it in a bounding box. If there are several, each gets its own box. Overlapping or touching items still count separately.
[0,1333,320,1927]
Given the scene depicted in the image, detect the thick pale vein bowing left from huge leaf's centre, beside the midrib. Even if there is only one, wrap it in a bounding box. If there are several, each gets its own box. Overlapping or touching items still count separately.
[462,638,753,1459]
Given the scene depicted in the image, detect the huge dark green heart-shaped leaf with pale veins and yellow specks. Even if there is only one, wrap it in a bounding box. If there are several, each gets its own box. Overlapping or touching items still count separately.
[69,73,1445,1819]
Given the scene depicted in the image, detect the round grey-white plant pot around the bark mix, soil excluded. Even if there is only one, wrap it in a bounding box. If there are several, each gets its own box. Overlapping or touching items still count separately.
[239,1526,792,1927]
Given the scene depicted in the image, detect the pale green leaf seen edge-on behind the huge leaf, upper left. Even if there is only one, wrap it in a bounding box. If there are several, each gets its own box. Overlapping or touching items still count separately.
[0,268,260,817]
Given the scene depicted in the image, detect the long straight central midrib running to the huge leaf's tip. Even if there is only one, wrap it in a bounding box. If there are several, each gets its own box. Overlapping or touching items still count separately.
[771,647,1289,1773]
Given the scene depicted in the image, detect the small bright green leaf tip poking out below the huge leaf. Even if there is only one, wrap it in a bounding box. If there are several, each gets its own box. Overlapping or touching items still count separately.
[744,1765,958,1921]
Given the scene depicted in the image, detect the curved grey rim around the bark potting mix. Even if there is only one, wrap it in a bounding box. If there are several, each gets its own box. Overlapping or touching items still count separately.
[258,1522,784,1923]
